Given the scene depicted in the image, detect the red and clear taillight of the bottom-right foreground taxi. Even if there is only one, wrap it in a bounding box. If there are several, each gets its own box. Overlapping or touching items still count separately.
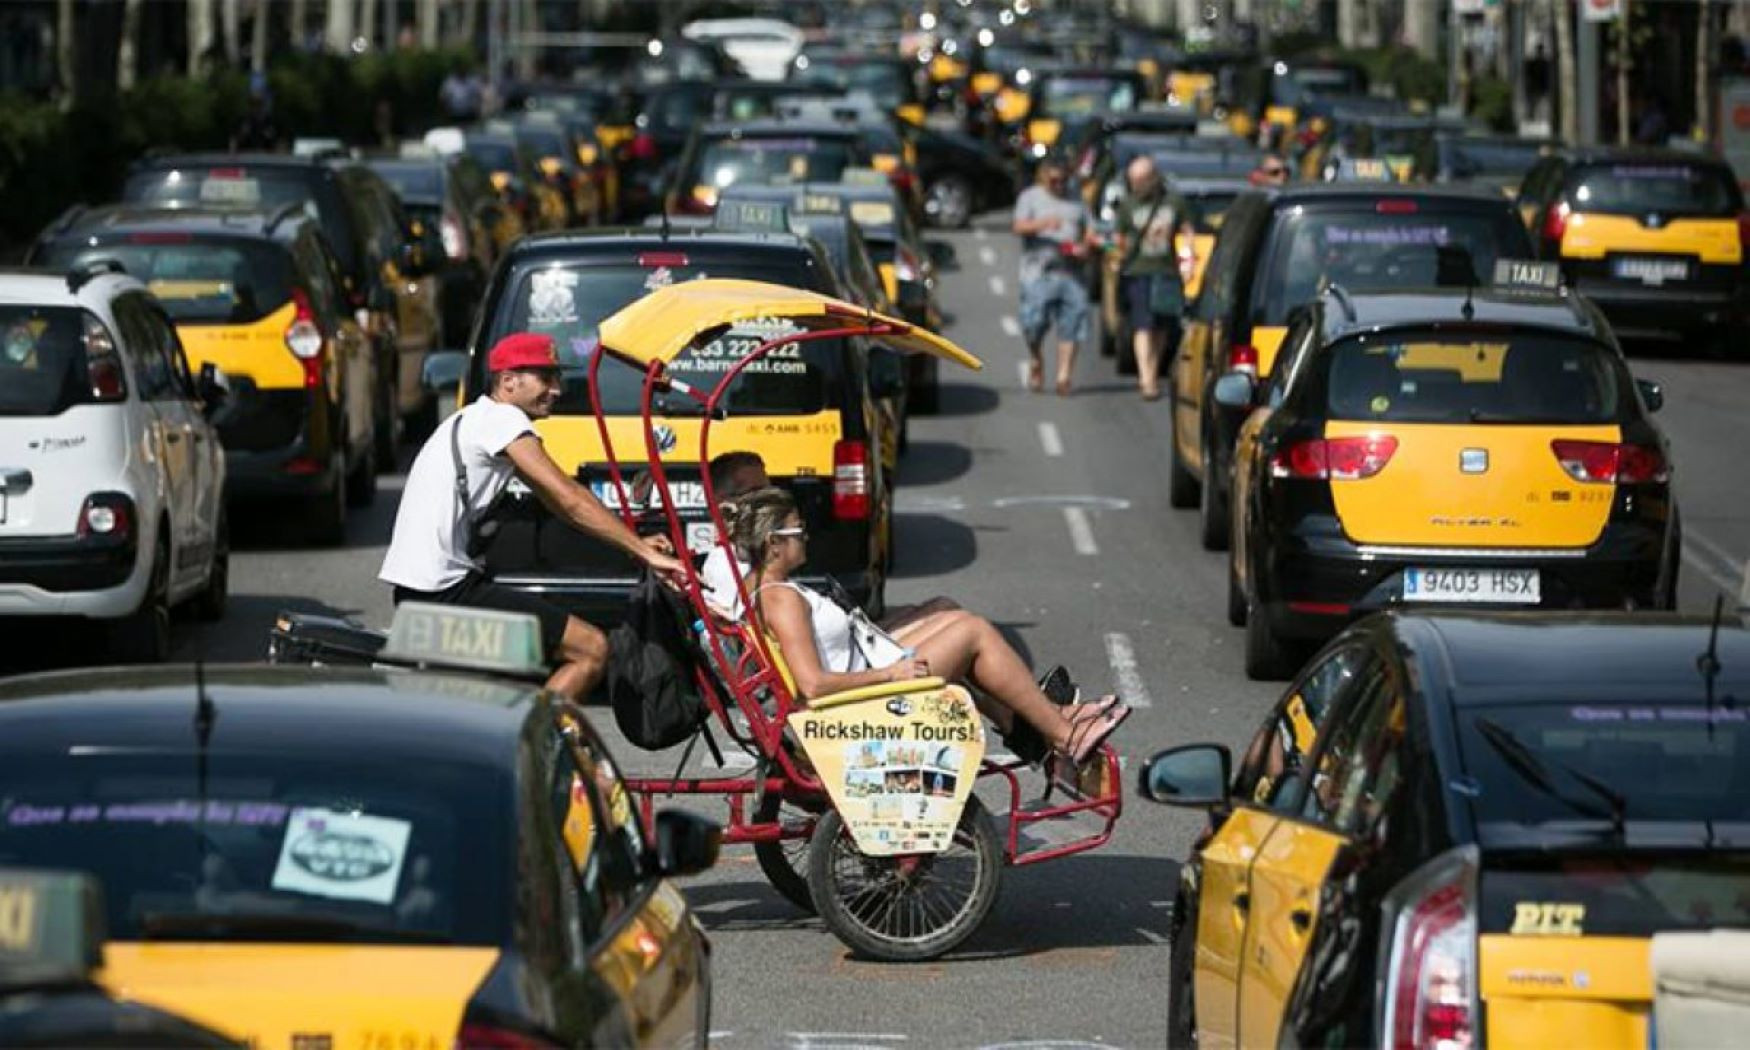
[1381,847,1479,1050]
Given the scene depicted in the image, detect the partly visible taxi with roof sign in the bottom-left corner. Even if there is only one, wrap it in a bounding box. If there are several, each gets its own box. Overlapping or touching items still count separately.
[0,868,240,1050]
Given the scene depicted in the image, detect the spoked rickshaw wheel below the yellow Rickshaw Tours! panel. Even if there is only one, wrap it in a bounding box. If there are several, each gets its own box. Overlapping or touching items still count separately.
[809,798,1003,963]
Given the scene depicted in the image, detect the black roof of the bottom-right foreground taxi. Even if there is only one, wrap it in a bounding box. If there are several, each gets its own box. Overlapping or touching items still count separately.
[1393,613,1750,707]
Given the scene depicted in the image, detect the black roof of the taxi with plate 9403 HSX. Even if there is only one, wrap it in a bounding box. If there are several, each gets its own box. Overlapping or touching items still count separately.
[1323,285,1607,341]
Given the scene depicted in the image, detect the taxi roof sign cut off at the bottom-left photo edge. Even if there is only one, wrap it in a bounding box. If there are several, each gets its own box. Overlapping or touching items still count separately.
[0,868,103,989]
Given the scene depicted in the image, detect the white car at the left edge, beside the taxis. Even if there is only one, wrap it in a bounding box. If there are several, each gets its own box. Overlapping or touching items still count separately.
[0,261,229,662]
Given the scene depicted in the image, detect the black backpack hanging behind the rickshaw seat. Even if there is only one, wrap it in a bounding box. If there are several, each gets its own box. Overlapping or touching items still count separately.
[607,569,711,751]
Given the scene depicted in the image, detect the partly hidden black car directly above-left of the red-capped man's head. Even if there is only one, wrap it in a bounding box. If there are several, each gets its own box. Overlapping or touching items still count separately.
[369,154,515,347]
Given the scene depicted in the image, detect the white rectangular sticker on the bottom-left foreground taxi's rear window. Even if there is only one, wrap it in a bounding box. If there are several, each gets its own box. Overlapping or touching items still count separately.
[273,809,413,905]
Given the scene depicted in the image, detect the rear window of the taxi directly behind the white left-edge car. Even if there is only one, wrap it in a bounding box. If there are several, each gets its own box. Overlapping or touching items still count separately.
[42,233,292,324]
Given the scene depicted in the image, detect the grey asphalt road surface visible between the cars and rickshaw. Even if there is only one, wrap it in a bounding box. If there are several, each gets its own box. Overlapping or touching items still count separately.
[12,217,1750,1048]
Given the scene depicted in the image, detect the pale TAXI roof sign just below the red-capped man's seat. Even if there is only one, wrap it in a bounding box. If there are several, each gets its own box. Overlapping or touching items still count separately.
[382,602,546,676]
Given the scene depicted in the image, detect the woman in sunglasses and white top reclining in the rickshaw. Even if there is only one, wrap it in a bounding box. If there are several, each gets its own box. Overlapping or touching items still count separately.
[723,488,1131,763]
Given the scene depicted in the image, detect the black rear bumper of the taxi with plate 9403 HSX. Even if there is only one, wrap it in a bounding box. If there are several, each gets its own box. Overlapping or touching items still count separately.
[1257,520,1666,641]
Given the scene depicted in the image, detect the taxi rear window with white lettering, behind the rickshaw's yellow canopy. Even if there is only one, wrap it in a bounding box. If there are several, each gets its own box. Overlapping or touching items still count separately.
[487,261,845,417]
